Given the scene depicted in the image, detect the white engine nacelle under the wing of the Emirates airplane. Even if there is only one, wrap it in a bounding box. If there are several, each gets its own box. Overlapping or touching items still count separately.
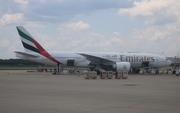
[113,62,131,71]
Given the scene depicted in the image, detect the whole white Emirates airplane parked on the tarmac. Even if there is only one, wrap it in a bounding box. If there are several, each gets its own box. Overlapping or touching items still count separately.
[15,26,171,72]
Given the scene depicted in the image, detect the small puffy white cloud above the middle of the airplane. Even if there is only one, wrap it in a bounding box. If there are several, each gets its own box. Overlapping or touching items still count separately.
[65,21,90,30]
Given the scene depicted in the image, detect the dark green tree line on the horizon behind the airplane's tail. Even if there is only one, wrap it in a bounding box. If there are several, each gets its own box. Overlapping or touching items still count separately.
[0,59,43,66]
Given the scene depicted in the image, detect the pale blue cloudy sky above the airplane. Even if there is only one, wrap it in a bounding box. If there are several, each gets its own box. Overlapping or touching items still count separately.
[0,0,180,59]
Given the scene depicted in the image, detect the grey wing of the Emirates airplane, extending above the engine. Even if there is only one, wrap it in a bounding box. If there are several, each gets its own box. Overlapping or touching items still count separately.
[79,53,114,64]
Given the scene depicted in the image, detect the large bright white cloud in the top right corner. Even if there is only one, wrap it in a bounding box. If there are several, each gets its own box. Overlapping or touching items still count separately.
[118,0,180,24]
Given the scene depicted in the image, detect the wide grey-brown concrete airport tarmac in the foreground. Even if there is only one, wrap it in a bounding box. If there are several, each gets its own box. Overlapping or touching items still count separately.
[0,70,180,113]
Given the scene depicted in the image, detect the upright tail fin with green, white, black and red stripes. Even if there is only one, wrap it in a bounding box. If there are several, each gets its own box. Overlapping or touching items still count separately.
[16,26,45,54]
